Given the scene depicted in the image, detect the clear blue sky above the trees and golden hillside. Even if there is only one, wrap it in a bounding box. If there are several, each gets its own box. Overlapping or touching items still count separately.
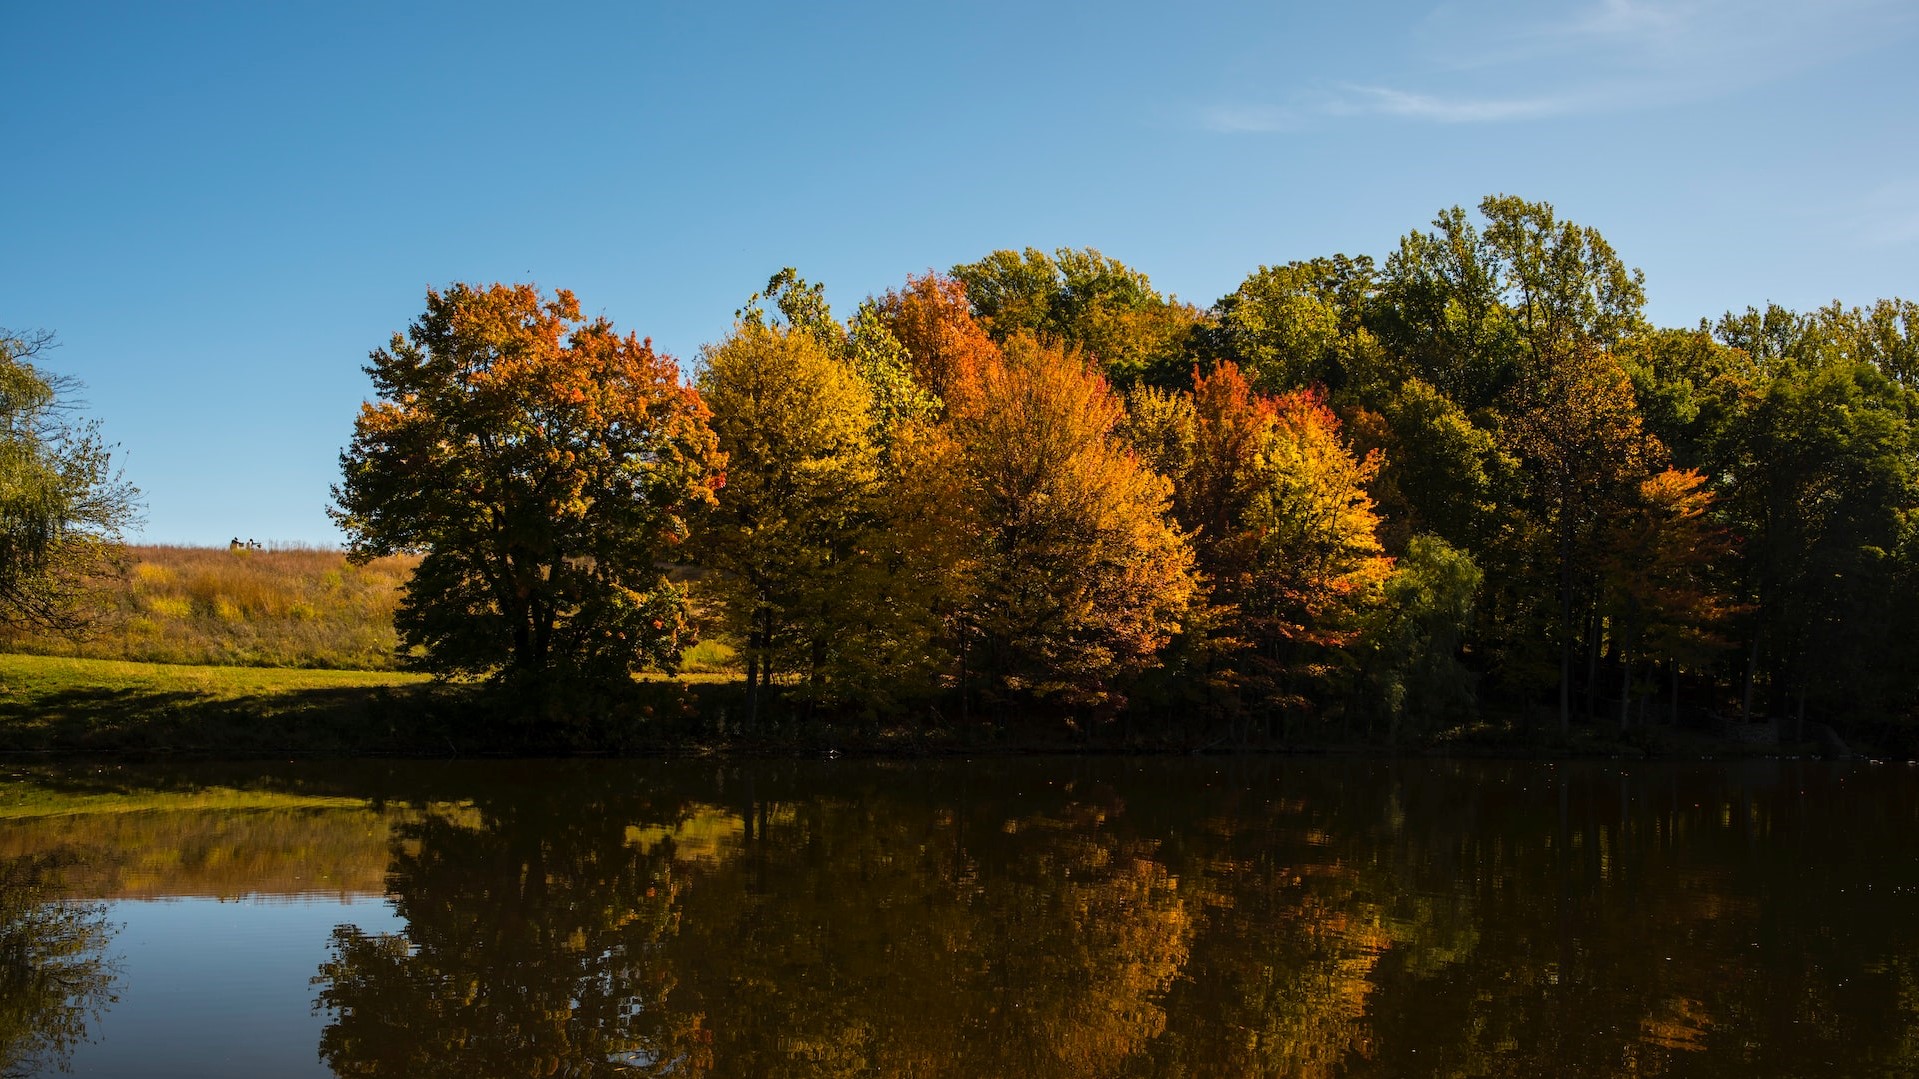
[0,0,1919,543]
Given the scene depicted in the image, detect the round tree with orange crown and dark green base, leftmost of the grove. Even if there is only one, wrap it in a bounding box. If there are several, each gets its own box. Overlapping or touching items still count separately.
[332,284,722,678]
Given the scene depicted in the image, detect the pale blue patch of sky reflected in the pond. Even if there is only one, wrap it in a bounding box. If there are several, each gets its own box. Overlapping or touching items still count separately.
[61,897,401,1079]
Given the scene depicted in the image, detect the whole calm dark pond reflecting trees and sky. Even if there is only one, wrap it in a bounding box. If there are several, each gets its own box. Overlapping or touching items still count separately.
[0,758,1919,1077]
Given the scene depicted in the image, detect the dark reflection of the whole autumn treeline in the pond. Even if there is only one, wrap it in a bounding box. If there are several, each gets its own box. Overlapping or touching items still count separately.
[317,762,1919,1077]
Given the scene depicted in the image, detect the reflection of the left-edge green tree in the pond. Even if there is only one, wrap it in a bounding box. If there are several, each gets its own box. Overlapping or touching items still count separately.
[0,858,115,1077]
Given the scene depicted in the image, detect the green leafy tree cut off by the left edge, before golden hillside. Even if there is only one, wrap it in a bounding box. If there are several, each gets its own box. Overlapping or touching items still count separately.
[0,322,140,634]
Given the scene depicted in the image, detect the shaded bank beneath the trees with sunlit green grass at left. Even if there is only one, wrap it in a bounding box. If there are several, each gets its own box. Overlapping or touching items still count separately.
[0,655,1909,760]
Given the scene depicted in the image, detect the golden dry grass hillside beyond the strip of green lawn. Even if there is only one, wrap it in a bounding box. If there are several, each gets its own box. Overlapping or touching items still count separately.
[0,547,418,670]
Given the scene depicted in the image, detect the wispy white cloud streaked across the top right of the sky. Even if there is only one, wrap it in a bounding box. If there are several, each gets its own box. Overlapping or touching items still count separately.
[1199,0,1919,132]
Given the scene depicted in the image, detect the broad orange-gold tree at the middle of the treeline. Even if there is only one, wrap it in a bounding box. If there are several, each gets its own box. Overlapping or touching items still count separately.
[906,338,1194,705]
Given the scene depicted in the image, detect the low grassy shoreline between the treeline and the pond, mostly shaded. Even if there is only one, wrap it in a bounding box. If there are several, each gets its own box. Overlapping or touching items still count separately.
[0,653,1904,760]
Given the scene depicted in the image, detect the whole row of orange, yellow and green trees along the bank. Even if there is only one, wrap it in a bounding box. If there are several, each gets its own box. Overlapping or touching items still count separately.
[336,196,1919,741]
